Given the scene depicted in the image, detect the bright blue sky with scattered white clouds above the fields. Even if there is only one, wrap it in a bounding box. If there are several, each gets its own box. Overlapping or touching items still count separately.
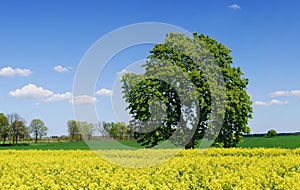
[0,0,300,136]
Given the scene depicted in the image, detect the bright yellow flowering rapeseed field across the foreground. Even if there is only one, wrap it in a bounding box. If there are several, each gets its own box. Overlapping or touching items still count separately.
[0,148,300,190]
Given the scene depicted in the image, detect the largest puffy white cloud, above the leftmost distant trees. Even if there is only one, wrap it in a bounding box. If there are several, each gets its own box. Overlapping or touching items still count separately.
[9,84,54,99]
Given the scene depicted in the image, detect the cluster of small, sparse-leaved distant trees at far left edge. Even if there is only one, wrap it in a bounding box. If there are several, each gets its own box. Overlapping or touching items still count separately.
[0,113,48,144]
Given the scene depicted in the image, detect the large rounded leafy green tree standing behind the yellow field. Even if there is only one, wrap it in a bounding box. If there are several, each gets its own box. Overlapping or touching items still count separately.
[122,33,252,148]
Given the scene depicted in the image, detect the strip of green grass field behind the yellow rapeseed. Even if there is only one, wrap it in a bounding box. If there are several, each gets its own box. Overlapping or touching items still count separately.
[0,135,300,150]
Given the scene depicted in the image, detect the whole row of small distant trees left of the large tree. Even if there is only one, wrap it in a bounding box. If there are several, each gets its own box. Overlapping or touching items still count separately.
[0,113,133,144]
